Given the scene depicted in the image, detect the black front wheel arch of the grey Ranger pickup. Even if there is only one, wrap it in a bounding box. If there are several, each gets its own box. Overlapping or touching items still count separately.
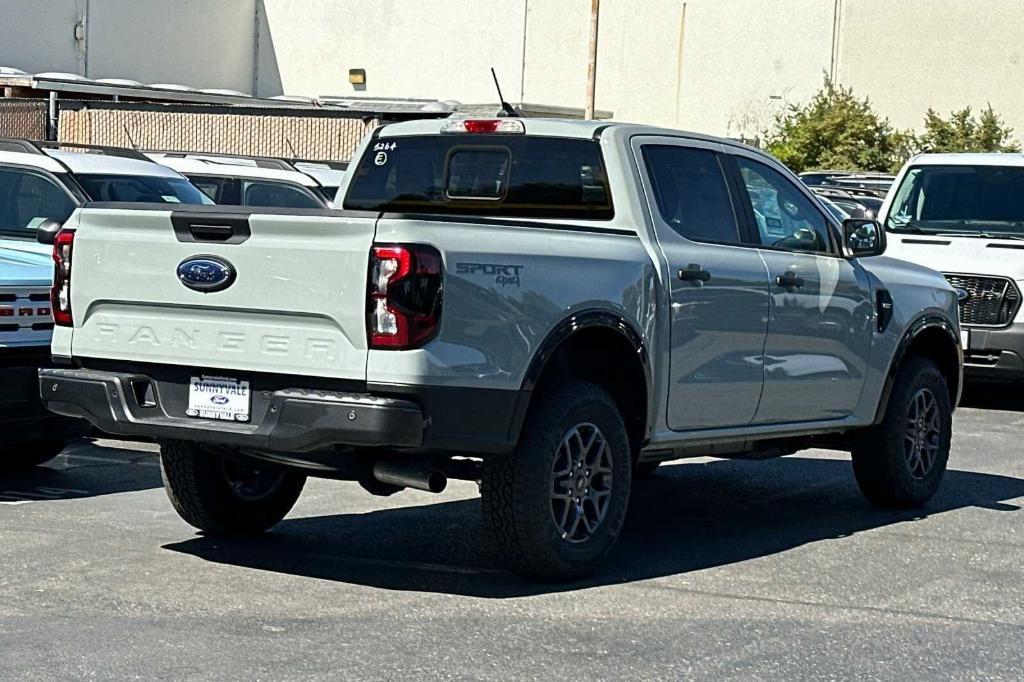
[874,314,964,424]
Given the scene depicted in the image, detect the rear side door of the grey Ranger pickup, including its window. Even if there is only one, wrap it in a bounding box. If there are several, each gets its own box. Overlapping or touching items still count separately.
[633,137,768,431]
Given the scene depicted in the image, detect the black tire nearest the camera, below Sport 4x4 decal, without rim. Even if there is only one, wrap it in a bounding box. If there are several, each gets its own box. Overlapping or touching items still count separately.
[480,381,633,581]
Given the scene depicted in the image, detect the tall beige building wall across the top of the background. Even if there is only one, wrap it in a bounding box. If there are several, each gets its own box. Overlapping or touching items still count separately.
[0,0,1024,137]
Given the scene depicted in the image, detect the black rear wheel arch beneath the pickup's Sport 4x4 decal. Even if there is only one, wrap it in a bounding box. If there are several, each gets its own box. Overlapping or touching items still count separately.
[522,309,653,457]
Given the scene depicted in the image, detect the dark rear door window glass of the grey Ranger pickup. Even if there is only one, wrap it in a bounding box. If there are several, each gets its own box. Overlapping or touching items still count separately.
[643,144,740,244]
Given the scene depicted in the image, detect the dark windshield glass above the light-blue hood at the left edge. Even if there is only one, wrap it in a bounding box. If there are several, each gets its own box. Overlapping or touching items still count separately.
[0,168,75,233]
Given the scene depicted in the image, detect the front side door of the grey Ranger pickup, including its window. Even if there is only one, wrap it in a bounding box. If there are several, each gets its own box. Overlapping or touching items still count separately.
[731,148,873,424]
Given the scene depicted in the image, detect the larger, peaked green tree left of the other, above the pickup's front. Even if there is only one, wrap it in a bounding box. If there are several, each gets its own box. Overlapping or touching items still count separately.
[766,75,909,173]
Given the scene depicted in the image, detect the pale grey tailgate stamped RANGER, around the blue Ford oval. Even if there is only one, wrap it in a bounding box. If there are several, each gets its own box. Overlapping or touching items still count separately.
[71,207,375,381]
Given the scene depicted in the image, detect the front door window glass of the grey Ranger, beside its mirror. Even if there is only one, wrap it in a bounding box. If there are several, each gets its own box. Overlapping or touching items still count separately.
[735,157,833,254]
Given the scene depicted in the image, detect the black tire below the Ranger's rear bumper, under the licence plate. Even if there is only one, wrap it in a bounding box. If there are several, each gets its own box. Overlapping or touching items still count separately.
[160,440,306,536]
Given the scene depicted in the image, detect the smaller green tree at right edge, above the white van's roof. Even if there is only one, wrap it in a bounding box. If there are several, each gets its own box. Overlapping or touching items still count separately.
[914,104,1021,152]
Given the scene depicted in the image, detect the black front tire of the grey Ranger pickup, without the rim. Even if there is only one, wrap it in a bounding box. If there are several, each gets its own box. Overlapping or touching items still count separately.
[852,357,952,508]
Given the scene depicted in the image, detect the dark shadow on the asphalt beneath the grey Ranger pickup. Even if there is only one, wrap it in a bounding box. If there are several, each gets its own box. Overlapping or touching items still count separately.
[165,457,1024,598]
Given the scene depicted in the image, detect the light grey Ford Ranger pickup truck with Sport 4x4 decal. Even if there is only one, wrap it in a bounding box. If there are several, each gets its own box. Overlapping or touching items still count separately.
[40,119,962,579]
